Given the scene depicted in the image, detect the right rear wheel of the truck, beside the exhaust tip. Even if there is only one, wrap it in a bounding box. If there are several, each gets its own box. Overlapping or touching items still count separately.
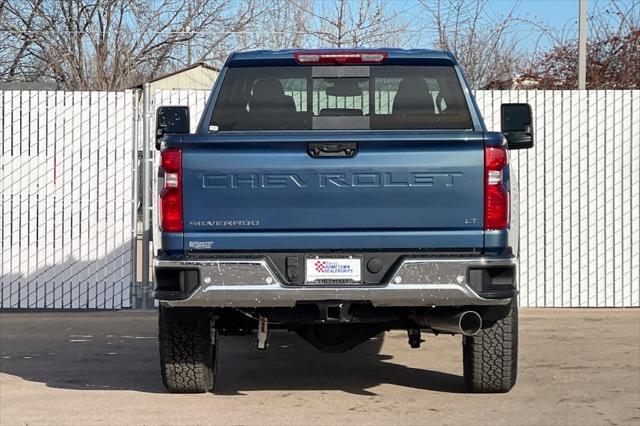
[462,301,518,393]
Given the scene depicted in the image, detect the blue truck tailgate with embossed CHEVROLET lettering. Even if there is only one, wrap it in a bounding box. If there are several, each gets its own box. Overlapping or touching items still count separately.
[182,131,484,251]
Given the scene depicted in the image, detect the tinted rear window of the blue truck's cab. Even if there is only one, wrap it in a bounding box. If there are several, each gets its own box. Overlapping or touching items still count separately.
[210,65,473,131]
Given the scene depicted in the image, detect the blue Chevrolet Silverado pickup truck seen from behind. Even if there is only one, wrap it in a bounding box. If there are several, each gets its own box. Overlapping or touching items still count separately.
[154,49,533,392]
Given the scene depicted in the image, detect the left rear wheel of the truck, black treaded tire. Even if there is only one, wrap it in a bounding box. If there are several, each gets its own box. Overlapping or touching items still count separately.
[158,306,218,393]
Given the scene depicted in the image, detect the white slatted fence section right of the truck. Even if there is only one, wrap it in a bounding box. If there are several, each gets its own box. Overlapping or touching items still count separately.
[476,90,640,307]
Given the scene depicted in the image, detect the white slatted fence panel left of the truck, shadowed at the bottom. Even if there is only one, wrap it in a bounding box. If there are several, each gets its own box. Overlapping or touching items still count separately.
[0,91,135,309]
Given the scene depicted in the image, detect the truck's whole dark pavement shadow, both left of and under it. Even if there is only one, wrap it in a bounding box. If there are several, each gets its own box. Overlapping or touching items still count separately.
[0,312,464,395]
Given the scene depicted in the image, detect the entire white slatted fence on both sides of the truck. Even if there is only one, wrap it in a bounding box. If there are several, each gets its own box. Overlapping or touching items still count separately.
[0,90,640,308]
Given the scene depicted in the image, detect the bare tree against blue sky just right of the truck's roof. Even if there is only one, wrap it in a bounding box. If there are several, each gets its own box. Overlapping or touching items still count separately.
[421,0,523,87]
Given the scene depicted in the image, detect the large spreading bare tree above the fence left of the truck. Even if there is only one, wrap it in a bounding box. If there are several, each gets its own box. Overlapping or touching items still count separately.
[0,0,255,90]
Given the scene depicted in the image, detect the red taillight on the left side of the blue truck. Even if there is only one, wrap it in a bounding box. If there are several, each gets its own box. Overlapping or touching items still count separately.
[160,148,183,232]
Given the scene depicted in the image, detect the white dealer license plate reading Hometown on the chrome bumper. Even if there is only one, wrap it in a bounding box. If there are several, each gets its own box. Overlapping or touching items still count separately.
[305,257,362,284]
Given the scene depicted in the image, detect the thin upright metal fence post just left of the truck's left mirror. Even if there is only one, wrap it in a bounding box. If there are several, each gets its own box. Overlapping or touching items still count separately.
[142,83,151,309]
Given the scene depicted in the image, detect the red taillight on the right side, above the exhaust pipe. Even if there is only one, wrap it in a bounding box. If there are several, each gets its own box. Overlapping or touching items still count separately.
[484,146,509,229]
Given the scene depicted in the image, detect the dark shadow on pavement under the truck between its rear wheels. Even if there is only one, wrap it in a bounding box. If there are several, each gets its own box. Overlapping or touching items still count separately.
[215,332,465,395]
